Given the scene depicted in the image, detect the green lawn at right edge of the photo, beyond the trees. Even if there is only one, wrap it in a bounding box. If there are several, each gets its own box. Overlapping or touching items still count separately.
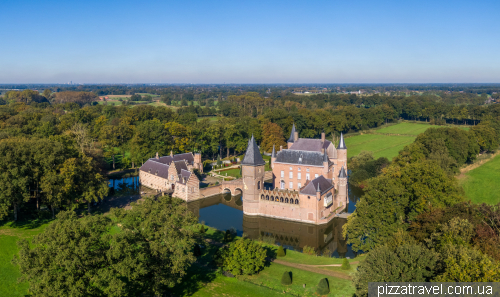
[461,155,500,204]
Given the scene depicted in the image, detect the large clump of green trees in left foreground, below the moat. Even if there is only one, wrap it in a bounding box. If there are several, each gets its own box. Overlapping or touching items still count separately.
[15,198,196,296]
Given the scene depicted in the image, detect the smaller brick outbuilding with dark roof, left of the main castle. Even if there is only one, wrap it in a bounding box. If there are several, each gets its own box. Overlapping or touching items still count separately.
[139,152,203,201]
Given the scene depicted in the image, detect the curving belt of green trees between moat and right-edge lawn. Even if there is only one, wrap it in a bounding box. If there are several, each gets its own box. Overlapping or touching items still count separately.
[343,161,463,251]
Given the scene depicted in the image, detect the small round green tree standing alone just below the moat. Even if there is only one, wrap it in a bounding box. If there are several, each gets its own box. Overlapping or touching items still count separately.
[219,239,266,275]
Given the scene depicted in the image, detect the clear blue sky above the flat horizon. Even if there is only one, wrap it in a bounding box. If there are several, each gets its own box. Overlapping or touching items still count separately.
[0,0,500,84]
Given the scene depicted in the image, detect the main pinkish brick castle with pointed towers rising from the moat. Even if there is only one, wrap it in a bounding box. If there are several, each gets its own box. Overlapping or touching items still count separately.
[239,125,348,224]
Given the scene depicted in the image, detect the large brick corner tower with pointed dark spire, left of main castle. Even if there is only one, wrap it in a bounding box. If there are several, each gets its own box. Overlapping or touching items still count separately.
[241,135,266,215]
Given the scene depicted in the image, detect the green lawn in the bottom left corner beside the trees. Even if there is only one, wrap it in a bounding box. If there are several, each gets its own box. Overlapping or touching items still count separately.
[0,217,48,297]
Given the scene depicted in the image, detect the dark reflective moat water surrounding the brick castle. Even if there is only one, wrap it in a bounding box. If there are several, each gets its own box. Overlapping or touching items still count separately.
[110,177,361,258]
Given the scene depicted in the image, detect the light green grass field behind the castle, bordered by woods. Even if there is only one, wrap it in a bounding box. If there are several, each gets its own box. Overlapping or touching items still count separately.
[345,122,469,160]
